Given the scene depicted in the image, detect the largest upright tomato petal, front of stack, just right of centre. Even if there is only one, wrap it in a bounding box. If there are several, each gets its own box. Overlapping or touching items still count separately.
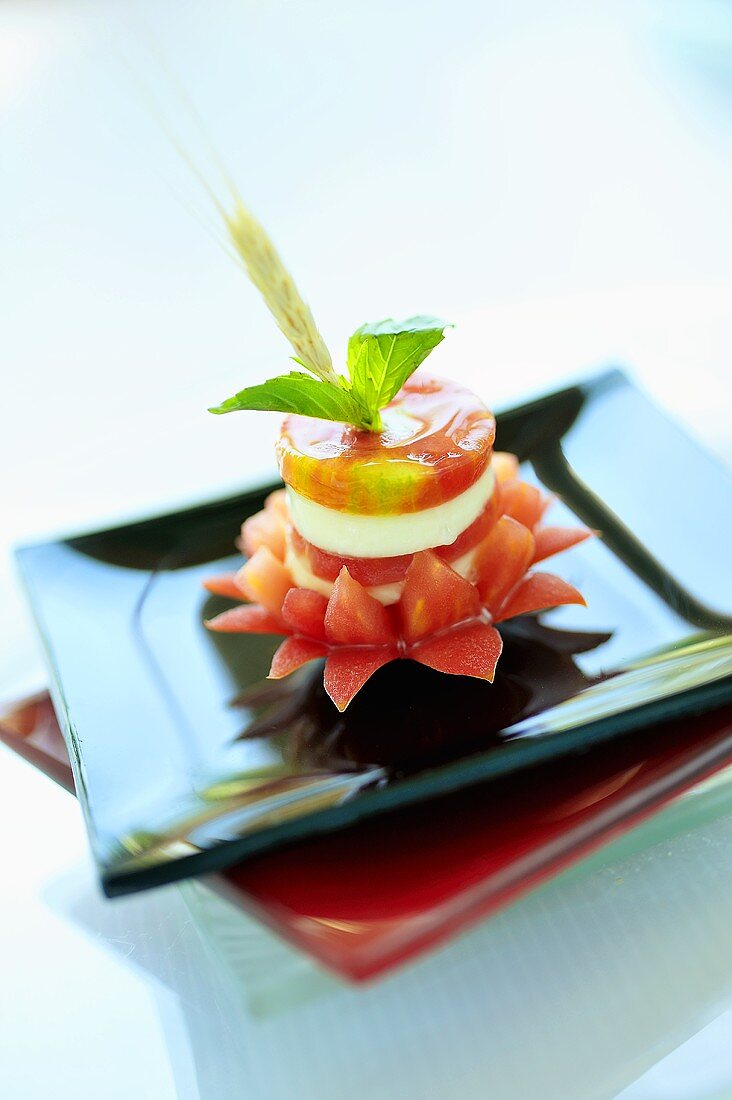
[398,550,481,642]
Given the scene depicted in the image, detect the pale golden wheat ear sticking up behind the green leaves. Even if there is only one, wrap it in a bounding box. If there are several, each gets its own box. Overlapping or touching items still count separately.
[225,197,338,385]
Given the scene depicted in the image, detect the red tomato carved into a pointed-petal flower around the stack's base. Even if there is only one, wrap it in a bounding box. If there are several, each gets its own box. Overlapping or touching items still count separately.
[206,454,591,711]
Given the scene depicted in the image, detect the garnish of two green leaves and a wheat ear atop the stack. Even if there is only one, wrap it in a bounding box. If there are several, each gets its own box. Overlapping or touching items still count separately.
[209,200,448,431]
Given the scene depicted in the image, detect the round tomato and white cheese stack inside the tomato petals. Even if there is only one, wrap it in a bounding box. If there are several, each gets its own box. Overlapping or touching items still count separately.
[277,377,499,604]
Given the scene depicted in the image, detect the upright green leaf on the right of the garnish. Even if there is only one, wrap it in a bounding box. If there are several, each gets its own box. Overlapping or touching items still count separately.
[348,317,448,428]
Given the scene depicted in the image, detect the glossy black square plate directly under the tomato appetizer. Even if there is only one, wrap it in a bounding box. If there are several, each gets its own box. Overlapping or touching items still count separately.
[18,371,732,894]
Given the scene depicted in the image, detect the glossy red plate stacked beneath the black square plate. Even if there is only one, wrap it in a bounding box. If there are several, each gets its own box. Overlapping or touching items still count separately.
[0,696,732,980]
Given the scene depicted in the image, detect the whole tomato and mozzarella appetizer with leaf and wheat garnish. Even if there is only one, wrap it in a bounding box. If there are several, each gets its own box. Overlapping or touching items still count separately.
[202,202,590,711]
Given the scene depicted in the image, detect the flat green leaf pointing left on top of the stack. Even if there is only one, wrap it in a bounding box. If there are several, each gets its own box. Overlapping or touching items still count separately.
[208,371,363,425]
